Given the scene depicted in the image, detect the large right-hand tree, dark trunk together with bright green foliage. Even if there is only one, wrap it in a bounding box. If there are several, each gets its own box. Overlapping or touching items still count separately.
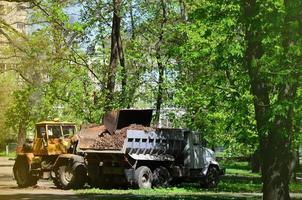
[177,0,301,199]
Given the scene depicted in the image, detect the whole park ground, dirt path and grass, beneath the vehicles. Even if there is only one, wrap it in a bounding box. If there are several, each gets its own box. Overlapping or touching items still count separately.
[0,157,302,200]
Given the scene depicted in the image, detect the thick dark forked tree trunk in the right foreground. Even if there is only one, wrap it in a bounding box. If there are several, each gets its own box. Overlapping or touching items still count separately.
[243,1,302,199]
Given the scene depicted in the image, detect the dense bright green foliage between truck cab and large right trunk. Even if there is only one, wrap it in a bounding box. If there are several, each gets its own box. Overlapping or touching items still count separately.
[169,1,257,155]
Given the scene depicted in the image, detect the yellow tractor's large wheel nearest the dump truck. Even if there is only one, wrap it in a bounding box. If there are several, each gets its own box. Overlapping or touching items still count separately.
[53,164,87,190]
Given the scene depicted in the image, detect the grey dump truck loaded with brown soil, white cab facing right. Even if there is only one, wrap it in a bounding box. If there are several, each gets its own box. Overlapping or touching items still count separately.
[74,110,224,188]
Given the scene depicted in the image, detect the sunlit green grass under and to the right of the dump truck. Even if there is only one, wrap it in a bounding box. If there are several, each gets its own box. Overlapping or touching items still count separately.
[77,162,302,200]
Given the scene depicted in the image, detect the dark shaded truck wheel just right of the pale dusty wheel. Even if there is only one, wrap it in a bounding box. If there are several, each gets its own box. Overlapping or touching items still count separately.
[152,166,171,187]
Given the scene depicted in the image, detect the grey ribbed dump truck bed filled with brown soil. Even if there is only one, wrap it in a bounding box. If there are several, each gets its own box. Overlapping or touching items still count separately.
[78,125,184,161]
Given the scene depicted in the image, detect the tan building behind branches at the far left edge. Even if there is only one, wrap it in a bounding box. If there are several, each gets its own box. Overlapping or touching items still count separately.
[0,0,28,148]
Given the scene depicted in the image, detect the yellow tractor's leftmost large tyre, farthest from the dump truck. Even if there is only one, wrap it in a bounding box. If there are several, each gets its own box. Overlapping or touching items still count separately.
[13,157,38,188]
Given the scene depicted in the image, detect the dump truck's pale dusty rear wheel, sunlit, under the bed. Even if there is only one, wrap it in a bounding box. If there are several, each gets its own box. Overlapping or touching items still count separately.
[134,166,153,189]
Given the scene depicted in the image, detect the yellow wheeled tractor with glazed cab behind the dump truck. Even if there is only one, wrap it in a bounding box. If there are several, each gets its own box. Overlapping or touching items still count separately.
[13,119,87,189]
